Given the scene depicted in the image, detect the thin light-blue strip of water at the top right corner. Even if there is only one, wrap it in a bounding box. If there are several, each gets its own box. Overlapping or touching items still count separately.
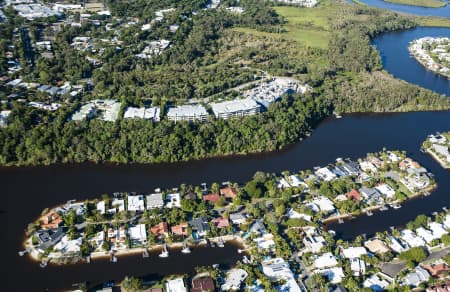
[350,0,450,18]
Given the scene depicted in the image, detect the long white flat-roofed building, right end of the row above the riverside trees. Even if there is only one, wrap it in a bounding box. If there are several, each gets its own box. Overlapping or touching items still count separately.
[211,98,261,120]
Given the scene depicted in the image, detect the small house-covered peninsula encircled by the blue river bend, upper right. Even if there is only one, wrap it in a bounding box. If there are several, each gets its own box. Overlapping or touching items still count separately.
[409,37,450,78]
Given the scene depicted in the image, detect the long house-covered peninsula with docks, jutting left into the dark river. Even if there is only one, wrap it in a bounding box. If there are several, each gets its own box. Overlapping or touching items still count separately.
[25,151,436,264]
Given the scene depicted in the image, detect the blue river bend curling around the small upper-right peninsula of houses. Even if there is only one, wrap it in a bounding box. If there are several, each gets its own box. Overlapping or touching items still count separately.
[372,26,450,97]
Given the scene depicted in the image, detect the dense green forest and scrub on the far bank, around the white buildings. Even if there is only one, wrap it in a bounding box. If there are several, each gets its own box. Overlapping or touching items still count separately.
[0,0,450,165]
